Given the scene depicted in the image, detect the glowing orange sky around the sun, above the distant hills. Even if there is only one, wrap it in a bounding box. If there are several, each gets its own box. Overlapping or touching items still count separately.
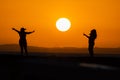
[0,0,120,47]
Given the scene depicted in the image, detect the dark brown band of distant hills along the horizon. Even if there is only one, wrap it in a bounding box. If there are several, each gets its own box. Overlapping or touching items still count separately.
[0,44,120,54]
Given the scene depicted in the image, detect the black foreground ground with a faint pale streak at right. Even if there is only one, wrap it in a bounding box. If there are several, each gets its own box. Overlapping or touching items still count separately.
[0,54,120,80]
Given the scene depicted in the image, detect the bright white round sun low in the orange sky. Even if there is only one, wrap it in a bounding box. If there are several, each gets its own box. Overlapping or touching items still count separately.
[56,18,71,32]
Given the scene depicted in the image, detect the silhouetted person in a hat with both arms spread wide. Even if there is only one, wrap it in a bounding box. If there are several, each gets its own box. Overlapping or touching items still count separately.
[12,28,35,55]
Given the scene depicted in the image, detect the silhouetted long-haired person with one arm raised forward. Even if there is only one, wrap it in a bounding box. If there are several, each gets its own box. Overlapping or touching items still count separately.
[83,29,97,57]
